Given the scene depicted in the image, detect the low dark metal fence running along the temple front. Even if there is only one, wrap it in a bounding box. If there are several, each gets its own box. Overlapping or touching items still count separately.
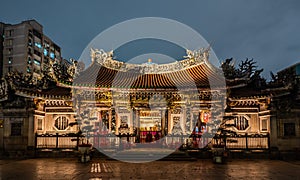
[35,134,270,150]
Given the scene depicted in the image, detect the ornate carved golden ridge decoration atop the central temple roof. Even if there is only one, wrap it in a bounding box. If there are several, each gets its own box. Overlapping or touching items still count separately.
[91,47,211,74]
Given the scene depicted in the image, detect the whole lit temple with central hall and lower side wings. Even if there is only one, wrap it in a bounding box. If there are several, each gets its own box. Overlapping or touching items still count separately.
[0,49,278,156]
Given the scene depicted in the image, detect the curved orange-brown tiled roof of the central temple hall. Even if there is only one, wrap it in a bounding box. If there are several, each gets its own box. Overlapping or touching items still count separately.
[73,58,225,89]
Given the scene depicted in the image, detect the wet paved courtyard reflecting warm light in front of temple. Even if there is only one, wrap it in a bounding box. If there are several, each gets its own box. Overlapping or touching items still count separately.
[0,158,300,180]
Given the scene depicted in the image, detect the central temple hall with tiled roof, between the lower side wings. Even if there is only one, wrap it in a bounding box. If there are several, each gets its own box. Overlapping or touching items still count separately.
[69,49,226,149]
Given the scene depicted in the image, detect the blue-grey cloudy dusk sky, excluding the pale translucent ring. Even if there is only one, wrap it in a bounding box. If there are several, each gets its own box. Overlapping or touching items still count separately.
[0,0,300,78]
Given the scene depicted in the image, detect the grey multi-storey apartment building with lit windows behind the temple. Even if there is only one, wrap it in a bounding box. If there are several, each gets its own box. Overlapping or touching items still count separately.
[0,20,62,79]
